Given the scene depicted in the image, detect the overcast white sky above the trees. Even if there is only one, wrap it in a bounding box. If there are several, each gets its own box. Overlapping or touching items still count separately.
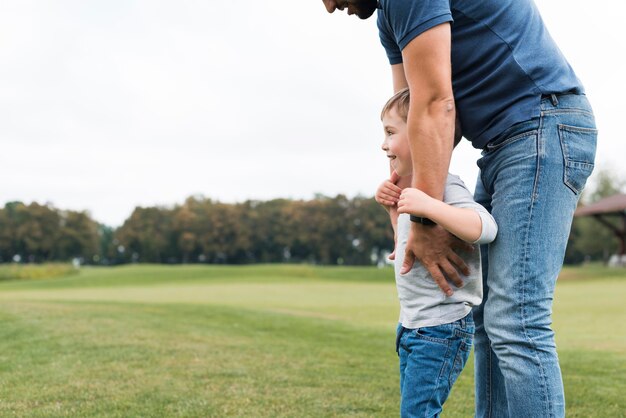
[0,0,626,226]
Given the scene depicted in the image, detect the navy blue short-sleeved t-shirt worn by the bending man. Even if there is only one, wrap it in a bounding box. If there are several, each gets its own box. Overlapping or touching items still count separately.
[378,0,584,148]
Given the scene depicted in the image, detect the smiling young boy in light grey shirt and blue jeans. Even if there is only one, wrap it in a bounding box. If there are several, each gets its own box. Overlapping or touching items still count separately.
[376,89,497,417]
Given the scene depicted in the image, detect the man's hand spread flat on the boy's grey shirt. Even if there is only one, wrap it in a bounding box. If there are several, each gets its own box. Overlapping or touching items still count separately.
[400,223,473,296]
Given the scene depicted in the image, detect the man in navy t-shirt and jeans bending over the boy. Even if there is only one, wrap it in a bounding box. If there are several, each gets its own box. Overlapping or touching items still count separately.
[322,0,597,418]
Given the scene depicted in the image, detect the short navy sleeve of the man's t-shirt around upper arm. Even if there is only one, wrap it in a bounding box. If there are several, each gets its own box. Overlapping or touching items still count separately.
[377,0,453,65]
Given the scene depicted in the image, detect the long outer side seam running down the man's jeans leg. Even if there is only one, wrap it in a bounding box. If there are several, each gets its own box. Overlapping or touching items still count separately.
[520,112,553,416]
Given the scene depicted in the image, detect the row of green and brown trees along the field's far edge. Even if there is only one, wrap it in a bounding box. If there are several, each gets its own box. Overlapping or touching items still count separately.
[0,171,626,265]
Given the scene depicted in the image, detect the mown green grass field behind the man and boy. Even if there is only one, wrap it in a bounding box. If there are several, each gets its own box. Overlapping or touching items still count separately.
[0,265,626,418]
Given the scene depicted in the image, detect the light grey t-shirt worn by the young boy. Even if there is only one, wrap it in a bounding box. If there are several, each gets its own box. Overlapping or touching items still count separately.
[394,174,497,329]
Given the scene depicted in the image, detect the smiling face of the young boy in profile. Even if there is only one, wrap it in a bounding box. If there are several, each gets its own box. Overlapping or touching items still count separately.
[382,107,413,177]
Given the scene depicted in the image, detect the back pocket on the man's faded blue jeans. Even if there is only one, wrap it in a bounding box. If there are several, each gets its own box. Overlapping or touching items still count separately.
[559,125,598,194]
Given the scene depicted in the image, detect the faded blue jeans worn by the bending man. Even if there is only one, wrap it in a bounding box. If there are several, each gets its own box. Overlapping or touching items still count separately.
[474,94,597,418]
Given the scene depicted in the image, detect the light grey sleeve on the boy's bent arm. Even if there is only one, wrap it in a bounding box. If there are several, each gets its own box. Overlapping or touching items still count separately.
[443,174,498,244]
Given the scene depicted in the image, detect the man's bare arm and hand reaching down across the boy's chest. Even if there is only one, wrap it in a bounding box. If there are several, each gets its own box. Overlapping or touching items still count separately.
[392,23,469,295]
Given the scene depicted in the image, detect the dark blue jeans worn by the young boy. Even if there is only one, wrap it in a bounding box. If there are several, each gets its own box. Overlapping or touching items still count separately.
[396,312,474,418]
